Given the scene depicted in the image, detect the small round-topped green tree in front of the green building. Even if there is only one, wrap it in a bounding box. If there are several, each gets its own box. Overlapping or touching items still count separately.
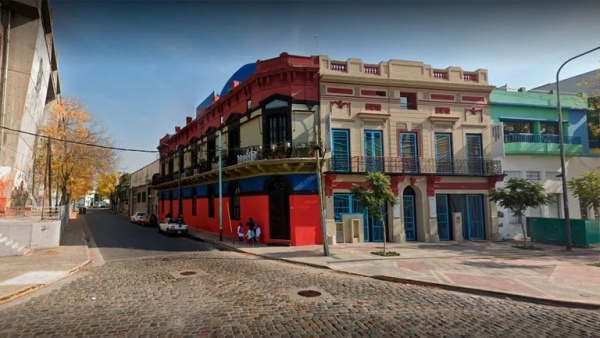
[488,177,553,248]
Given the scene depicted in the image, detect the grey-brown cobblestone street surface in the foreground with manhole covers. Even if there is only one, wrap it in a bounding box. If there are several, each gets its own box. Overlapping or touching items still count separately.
[0,251,600,337]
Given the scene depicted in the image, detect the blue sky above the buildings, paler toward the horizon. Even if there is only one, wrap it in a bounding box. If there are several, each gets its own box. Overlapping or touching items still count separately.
[50,0,600,173]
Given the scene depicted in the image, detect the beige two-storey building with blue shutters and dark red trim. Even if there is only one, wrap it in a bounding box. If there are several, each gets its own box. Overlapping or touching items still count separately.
[319,56,502,242]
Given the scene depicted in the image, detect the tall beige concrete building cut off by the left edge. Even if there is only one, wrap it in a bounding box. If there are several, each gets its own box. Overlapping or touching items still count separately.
[0,0,60,212]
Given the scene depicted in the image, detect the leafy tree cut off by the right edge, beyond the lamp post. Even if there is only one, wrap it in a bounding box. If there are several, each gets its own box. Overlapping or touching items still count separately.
[568,171,600,220]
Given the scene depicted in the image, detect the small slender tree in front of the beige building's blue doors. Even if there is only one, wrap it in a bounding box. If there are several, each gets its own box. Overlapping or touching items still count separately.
[350,172,398,256]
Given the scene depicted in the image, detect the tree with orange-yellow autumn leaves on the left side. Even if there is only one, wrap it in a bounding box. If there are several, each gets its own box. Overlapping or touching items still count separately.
[36,98,118,205]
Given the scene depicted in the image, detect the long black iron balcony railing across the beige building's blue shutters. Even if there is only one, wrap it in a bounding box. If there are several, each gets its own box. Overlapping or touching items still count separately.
[328,156,502,176]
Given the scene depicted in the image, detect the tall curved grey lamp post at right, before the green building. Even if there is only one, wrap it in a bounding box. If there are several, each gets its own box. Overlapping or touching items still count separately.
[556,46,600,251]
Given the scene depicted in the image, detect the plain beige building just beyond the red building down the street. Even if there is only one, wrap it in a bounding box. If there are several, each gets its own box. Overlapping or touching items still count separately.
[129,160,159,215]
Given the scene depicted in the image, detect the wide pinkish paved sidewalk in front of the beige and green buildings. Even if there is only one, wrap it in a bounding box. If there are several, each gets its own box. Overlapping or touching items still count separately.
[191,230,600,309]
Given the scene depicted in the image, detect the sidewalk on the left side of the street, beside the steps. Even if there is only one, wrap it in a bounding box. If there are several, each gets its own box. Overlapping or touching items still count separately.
[0,213,91,304]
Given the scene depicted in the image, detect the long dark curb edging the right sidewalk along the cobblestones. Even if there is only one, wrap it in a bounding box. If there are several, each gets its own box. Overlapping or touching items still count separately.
[191,236,600,310]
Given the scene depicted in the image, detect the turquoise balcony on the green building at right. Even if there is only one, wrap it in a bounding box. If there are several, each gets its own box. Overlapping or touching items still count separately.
[504,134,583,156]
